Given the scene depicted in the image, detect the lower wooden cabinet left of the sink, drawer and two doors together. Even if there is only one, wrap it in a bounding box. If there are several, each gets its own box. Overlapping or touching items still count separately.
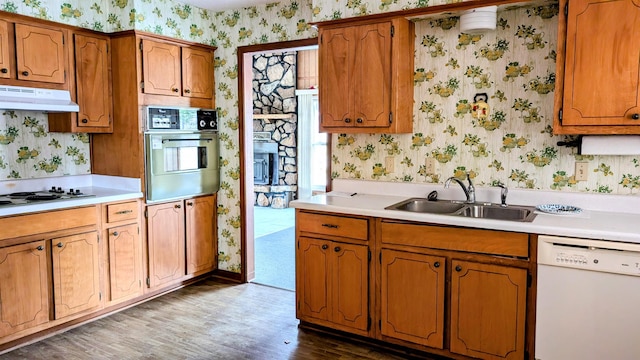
[296,212,371,335]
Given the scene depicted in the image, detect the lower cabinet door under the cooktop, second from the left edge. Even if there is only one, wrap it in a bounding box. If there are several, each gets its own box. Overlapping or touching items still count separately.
[51,232,100,319]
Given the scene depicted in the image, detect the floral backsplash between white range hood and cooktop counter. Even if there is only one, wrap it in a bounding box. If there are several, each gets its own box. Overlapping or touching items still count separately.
[0,110,91,180]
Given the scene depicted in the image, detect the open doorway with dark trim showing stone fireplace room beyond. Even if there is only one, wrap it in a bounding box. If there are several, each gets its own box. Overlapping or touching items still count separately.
[238,39,329,290]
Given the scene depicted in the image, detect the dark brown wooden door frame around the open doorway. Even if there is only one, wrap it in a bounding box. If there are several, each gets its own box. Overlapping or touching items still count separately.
[237,38,322,283]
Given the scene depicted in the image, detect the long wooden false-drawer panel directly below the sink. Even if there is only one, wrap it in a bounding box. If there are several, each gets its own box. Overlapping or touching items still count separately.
[381,222,529,257]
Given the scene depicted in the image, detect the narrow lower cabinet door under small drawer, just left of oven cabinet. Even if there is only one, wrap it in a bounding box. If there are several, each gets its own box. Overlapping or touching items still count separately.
[109,224,142,301]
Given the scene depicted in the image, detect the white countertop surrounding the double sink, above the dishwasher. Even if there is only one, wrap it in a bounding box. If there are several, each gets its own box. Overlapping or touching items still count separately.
[290,181,640,243]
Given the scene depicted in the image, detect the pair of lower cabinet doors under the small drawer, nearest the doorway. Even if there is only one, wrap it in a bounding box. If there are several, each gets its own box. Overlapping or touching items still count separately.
[296,237,369,331]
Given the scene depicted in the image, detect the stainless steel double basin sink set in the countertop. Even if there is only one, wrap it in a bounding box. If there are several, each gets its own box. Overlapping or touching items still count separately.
[385,198,536,222]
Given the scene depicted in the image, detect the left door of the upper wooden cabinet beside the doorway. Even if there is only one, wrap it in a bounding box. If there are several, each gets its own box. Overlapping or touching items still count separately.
[319,27,356,127]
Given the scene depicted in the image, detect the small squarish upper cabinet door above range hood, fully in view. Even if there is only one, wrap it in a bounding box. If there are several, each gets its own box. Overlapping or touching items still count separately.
[16,24,65,84]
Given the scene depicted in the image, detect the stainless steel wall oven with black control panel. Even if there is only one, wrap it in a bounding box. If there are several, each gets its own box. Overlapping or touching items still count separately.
[144,107,220,203]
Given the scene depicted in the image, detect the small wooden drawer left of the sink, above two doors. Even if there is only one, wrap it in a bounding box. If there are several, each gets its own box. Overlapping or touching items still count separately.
[296,212,369,241]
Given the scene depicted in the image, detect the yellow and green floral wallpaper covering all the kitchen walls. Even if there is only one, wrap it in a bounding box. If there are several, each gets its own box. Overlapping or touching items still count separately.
[0,0,640,272]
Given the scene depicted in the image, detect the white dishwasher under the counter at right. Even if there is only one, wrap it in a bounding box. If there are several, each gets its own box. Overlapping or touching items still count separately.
[535,236,640,360]
